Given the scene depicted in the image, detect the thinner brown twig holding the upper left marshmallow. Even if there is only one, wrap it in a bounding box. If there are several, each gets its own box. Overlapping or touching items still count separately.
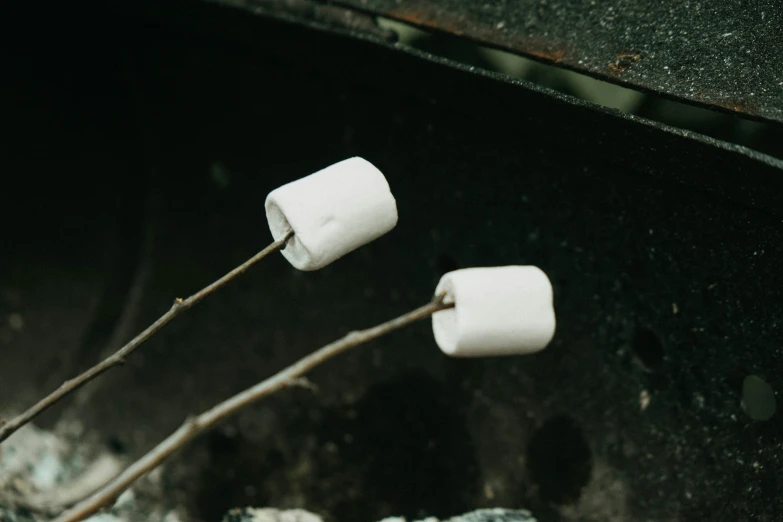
[0,232,294,443]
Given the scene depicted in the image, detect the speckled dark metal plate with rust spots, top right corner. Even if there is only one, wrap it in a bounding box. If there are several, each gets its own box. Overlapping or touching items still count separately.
[333,0,783,122]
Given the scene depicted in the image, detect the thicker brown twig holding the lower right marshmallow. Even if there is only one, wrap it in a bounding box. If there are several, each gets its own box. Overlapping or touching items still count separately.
[53,297,454,522]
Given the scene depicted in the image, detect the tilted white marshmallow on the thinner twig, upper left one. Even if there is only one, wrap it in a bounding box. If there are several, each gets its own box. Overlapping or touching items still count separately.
[266,158,397,270]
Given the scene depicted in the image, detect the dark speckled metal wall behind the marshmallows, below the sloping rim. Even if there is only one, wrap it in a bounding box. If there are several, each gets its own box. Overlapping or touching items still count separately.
[0,4,783,522]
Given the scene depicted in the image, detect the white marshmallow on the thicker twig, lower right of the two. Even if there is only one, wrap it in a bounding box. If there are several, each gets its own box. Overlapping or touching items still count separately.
[432,266,555,357]
